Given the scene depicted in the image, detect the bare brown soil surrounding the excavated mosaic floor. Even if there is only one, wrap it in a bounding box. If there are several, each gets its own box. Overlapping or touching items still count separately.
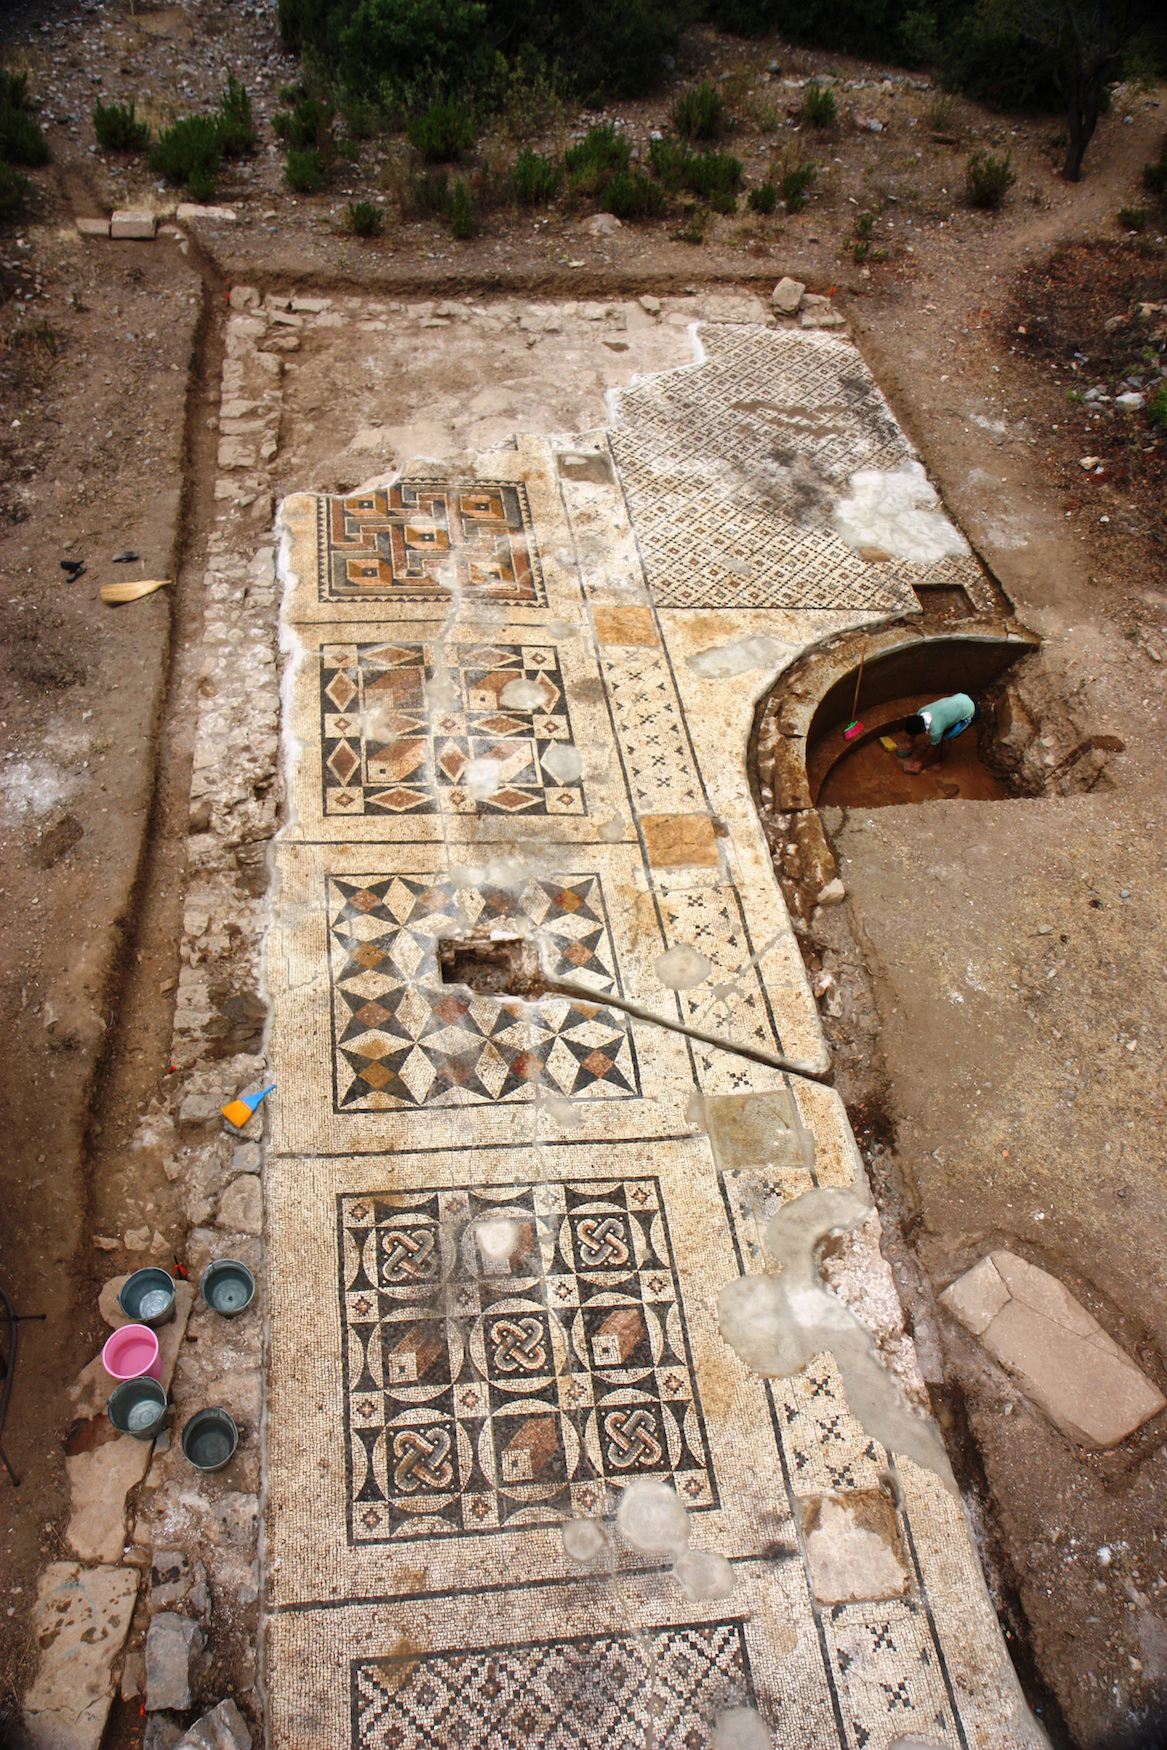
[0,0,1167,1747]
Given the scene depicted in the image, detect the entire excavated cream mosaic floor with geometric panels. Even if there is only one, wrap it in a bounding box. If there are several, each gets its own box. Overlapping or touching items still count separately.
[266,327,1043,1750]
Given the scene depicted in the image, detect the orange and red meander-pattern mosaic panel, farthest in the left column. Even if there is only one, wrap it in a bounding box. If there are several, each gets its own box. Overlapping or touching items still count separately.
[317,480,548,607]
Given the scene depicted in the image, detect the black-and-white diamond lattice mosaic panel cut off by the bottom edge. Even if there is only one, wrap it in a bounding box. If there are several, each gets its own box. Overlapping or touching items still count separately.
[352,1621,754,1750]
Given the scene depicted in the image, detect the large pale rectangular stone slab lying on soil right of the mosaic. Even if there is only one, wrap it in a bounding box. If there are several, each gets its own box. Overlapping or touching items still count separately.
[941,1251,1167,1451]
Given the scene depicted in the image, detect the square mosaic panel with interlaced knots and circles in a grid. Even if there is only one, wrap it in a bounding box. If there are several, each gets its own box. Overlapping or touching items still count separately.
[338,1178,714,1544]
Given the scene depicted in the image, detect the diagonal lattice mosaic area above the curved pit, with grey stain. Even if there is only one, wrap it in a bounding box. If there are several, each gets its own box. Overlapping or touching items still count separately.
[611,324,985,613]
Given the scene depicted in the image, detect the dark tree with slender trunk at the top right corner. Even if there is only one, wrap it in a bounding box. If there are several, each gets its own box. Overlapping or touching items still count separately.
[985,0,1167,182]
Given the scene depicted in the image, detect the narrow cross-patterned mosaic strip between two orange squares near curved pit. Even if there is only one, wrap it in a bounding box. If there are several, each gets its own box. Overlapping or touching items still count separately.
[600,648,705,814]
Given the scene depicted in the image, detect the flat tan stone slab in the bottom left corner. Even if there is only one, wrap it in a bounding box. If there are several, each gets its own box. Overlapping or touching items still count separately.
[24,1561,138,1750]
